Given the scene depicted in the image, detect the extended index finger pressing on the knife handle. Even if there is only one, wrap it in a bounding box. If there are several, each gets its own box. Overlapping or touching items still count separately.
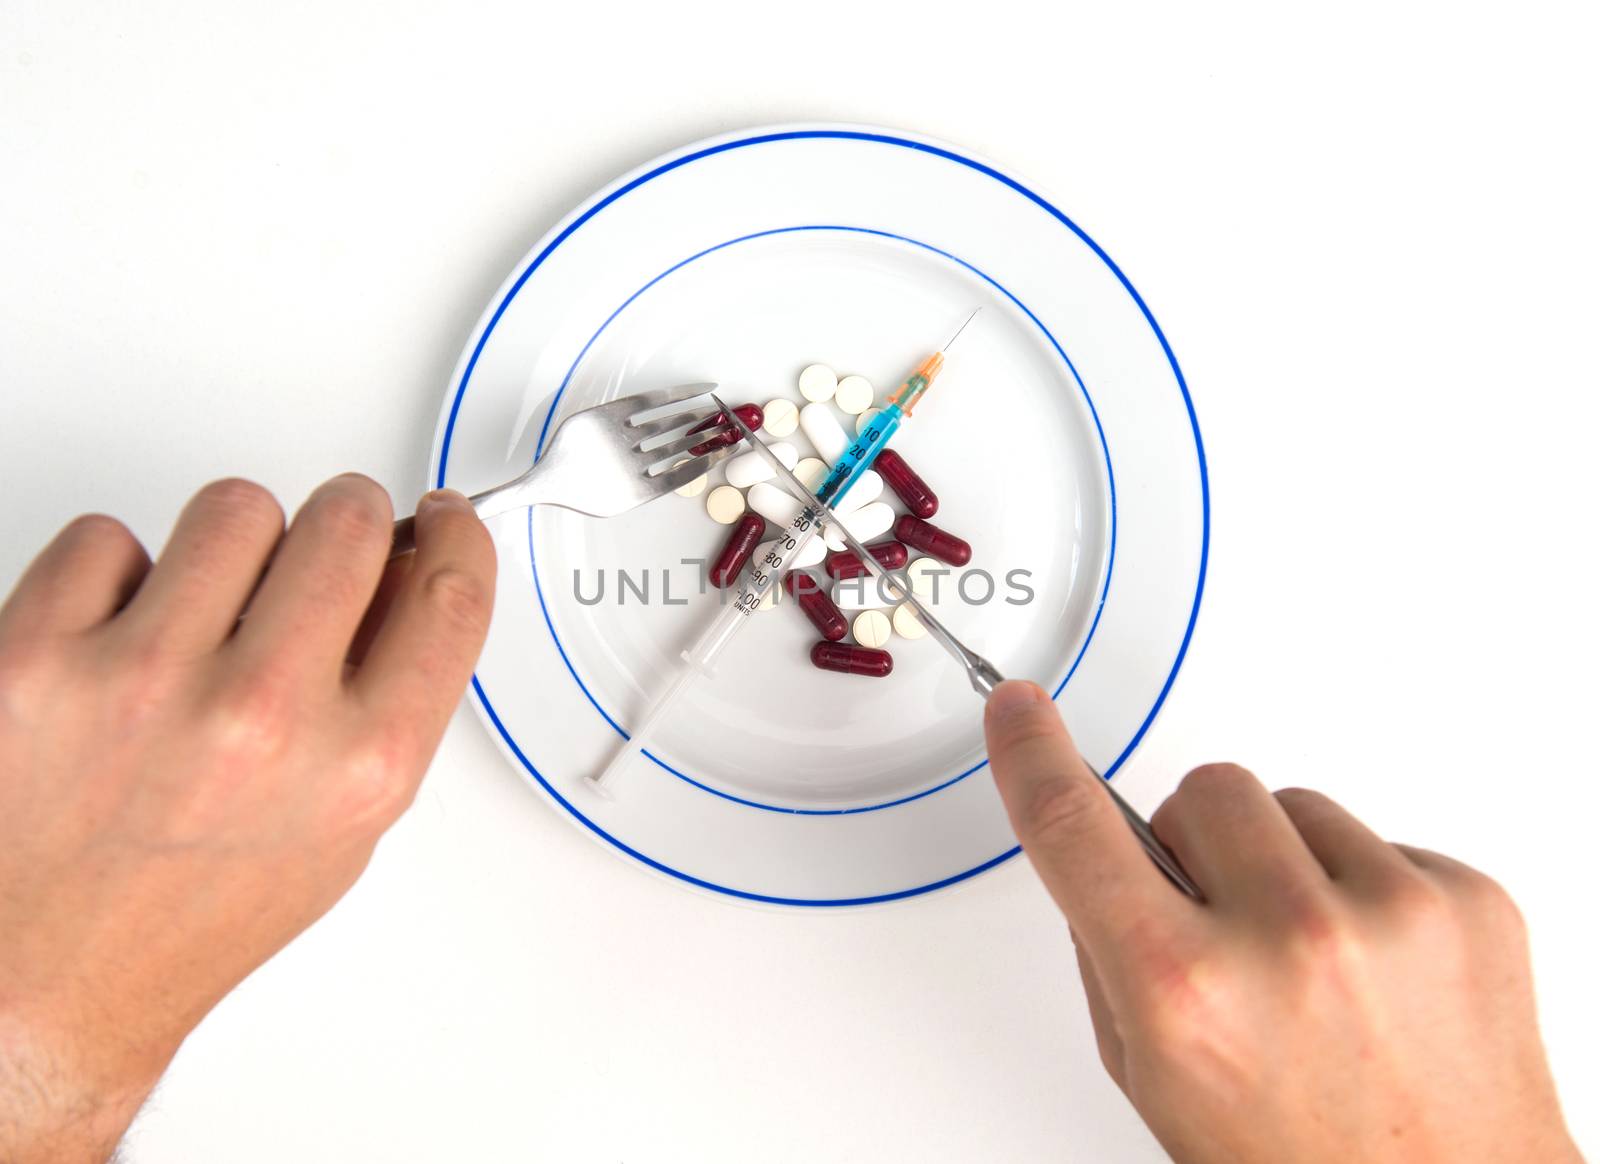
[984,680,1195,959]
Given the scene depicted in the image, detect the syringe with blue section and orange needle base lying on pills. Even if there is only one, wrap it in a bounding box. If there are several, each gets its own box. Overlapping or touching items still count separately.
[589,307,981,791]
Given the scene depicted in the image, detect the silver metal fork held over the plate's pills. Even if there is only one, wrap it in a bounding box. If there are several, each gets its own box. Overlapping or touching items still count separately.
[389,384,738,558]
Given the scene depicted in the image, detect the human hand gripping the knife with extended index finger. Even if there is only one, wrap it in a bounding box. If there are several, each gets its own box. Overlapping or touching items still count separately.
[984,683,1579,1164]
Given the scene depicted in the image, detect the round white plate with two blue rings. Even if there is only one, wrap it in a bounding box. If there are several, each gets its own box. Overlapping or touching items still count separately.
[430,126,1210,905]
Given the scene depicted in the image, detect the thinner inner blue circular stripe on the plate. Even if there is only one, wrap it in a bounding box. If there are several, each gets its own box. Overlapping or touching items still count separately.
[528,225,1117,817]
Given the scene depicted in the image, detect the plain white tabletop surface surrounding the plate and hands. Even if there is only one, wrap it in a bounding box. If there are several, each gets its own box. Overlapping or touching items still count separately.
[0,0,1600,1164]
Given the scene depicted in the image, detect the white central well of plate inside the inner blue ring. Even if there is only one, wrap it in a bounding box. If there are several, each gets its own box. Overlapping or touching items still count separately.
[530,229,1112,811]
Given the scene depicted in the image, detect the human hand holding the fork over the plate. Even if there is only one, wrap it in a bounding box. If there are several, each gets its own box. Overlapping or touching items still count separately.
[0,475,494,1164]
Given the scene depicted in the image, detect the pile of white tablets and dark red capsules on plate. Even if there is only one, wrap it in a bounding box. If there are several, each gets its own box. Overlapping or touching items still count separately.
[678,365,973,678]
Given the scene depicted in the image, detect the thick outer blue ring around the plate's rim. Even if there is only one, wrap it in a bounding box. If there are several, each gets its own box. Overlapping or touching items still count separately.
[435,130,1211,907]
